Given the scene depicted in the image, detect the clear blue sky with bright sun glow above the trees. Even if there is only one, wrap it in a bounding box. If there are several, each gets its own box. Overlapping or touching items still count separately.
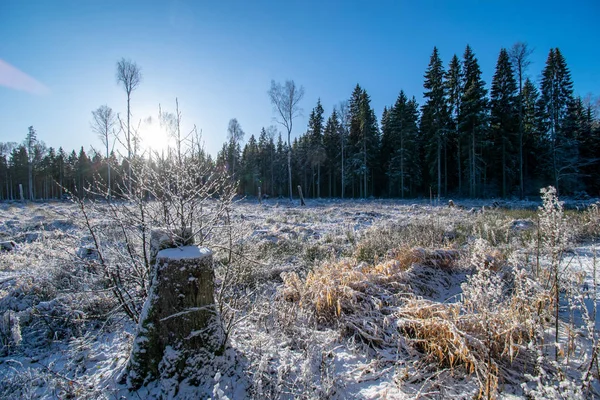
[0,0,600,155]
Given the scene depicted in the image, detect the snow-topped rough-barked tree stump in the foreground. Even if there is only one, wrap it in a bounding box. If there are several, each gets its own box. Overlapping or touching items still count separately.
[127,246,224,390]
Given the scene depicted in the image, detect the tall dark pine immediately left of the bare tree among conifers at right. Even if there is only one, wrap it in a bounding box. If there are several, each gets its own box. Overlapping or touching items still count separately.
[488,49,519,197]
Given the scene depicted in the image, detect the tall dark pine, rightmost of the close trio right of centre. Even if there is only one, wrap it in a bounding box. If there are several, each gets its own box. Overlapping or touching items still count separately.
[459,45,487,196]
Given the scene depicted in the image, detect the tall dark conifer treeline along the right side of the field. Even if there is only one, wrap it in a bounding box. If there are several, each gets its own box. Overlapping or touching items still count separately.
[216,43,600,198]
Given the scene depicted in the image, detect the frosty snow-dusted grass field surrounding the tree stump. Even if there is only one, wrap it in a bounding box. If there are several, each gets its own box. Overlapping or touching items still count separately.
[0,199,600,399]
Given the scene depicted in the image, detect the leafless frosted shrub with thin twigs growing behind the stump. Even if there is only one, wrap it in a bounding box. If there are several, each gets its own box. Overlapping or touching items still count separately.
[76,101,236,321]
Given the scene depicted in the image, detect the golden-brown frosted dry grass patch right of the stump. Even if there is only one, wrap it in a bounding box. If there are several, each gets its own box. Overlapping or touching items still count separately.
[282,242,550,397]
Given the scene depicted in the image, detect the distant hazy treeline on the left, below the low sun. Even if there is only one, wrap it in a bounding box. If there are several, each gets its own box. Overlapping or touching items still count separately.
[0,127,215,200]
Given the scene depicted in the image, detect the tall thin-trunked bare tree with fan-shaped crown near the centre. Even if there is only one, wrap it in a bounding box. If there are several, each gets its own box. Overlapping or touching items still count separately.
[268,80,304,201]
